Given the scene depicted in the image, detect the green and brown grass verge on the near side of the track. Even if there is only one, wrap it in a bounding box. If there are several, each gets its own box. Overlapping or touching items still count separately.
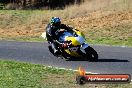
[0,60,132,88]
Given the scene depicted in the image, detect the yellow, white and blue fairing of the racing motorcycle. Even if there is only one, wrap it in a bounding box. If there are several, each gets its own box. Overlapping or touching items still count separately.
[60,30,85,57]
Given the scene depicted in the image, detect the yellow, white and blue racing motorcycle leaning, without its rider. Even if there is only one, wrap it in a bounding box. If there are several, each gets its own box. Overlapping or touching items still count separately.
[42,29,98,61]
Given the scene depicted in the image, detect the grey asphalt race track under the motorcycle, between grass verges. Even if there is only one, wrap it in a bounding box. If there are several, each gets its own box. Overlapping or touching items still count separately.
[0,41,132,75]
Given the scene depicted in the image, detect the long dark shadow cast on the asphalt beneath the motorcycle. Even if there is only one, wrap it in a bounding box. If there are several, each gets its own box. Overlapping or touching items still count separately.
[66,58,129,62]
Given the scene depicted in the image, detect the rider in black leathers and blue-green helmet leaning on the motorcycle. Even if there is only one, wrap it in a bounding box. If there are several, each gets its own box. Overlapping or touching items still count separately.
[46,17,72,55]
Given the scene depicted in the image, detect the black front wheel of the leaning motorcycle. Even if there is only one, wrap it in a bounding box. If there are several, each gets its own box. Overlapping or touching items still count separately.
[85,46,98,62]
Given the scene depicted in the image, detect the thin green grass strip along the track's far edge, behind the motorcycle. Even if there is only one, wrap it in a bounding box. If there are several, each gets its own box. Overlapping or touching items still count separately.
[1,36,132,47]
